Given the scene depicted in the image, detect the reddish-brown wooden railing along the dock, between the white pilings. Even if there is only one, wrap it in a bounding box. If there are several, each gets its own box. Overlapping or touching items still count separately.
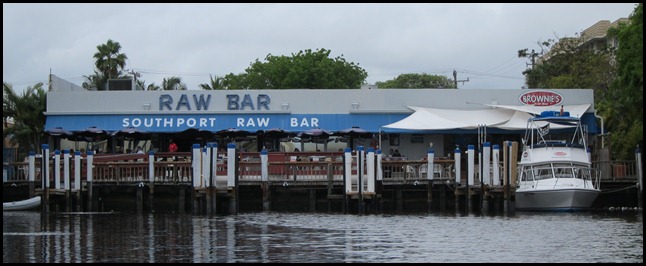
[3,152,638,188]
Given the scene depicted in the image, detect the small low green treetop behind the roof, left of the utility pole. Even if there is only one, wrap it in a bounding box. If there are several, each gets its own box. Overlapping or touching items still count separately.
[375,73,455,89]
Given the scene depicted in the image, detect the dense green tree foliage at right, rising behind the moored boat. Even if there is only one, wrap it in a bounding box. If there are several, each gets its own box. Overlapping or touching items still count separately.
[518,4,644,160]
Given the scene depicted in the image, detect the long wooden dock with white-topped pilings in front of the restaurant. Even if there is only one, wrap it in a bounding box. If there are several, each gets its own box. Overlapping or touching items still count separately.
[3,145,641,214]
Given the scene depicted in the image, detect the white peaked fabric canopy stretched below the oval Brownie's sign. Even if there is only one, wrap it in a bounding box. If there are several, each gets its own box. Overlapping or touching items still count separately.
[384,104,590,130]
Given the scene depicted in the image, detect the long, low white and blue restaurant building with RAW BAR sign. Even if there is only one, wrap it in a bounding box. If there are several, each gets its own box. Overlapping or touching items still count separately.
[45,79,603,159]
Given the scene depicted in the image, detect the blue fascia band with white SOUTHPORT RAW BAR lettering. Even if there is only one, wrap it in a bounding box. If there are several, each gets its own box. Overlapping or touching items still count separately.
[45,113,601,134]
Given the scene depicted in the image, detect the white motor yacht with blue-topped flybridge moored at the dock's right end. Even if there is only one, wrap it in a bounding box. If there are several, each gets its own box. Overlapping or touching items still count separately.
[515,109,601,211]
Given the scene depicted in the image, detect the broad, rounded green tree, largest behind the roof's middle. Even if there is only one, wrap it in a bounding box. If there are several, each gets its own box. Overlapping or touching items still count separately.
[222,49,368,89]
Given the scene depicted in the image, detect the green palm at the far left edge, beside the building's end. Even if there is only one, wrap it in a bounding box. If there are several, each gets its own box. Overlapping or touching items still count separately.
[2,82,47,156]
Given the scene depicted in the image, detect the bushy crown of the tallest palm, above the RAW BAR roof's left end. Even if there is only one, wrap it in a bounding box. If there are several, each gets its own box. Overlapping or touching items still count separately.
[94,39,128,79]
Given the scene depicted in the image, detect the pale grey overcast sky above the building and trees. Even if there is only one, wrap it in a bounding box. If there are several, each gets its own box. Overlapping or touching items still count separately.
[2,3,636,91]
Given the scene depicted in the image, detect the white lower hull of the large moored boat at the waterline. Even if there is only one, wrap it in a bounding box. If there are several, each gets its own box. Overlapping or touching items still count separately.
[515,189,600,211]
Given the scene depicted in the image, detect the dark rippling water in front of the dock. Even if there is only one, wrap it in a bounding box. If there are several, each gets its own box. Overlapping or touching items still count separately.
[2,212,644,263]
